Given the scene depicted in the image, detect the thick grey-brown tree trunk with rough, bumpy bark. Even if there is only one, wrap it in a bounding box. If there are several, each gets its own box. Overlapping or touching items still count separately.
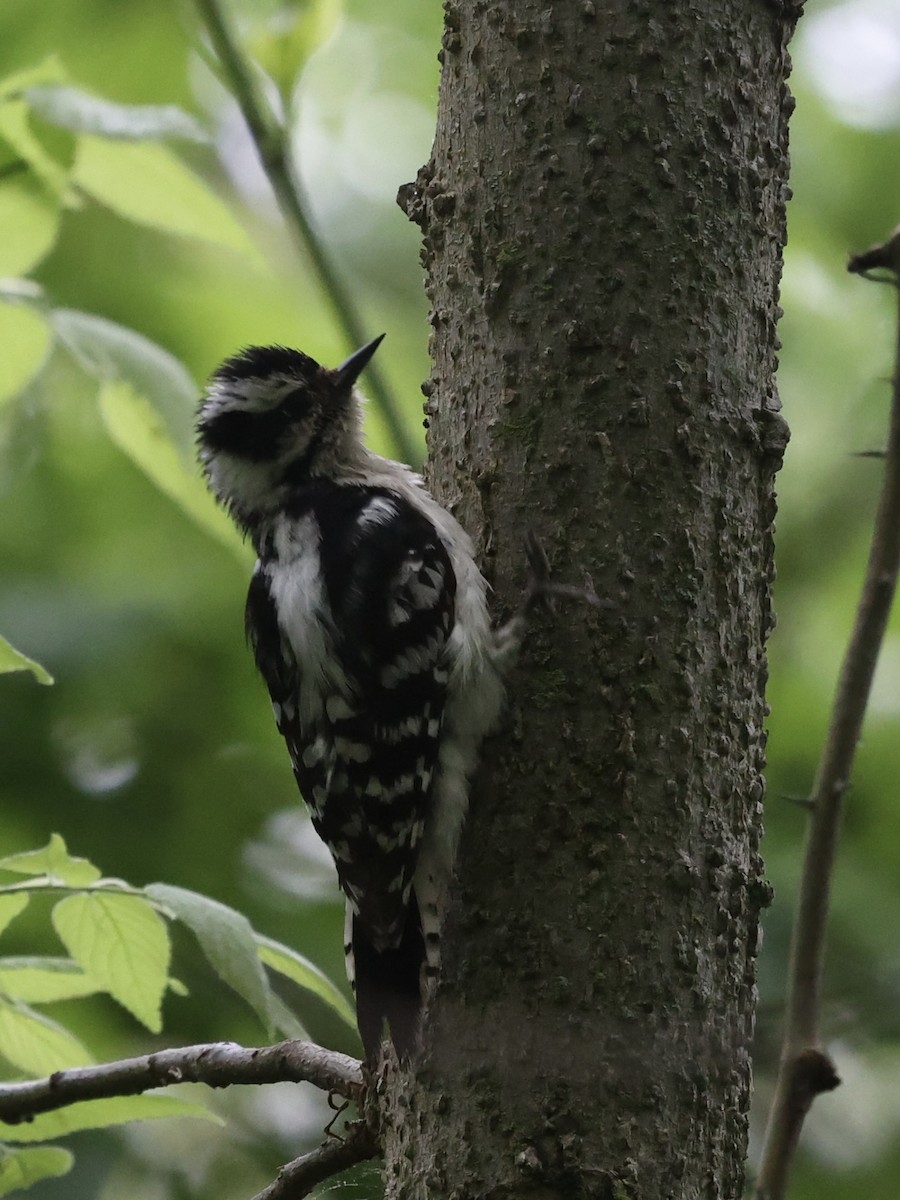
[383,0,792,1200]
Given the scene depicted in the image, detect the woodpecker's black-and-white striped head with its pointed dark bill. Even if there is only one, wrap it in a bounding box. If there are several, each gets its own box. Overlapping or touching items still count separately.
[197,334,384,527]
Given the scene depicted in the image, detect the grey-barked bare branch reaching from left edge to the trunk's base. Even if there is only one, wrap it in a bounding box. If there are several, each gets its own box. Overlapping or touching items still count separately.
[0,1042,364,1124]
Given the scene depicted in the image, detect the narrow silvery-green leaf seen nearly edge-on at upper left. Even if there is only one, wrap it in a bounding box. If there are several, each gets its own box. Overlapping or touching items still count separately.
[24,83,209,142]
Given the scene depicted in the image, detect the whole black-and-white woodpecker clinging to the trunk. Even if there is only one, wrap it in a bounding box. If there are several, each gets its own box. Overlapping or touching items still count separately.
[198,338,502,1060]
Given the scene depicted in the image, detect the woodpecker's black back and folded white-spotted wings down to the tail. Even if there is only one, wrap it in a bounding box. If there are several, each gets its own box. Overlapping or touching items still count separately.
[247,487,456,1051]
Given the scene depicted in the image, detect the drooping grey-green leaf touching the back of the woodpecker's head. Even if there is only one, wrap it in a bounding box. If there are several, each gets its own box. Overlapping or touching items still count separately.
[50,308,198,451]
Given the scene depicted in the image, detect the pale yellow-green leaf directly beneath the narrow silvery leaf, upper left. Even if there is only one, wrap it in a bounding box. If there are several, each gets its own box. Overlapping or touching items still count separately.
[73,134,259,264]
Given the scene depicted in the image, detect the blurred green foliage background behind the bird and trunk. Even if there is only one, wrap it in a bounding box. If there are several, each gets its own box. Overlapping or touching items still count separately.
[0,0,900,1200]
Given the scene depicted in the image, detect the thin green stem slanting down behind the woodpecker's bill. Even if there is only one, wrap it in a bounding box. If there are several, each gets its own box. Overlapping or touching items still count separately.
[196,0,420,462]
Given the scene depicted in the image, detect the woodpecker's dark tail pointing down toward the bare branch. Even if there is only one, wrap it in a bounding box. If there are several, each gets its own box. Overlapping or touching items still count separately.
[344,900,425,1063]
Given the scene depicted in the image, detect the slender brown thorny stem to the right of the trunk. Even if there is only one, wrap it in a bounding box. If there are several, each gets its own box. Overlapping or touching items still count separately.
[756,230,900,1200]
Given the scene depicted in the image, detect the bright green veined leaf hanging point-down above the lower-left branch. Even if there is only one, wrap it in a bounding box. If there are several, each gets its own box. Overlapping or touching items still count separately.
[53,890,169,1033]
